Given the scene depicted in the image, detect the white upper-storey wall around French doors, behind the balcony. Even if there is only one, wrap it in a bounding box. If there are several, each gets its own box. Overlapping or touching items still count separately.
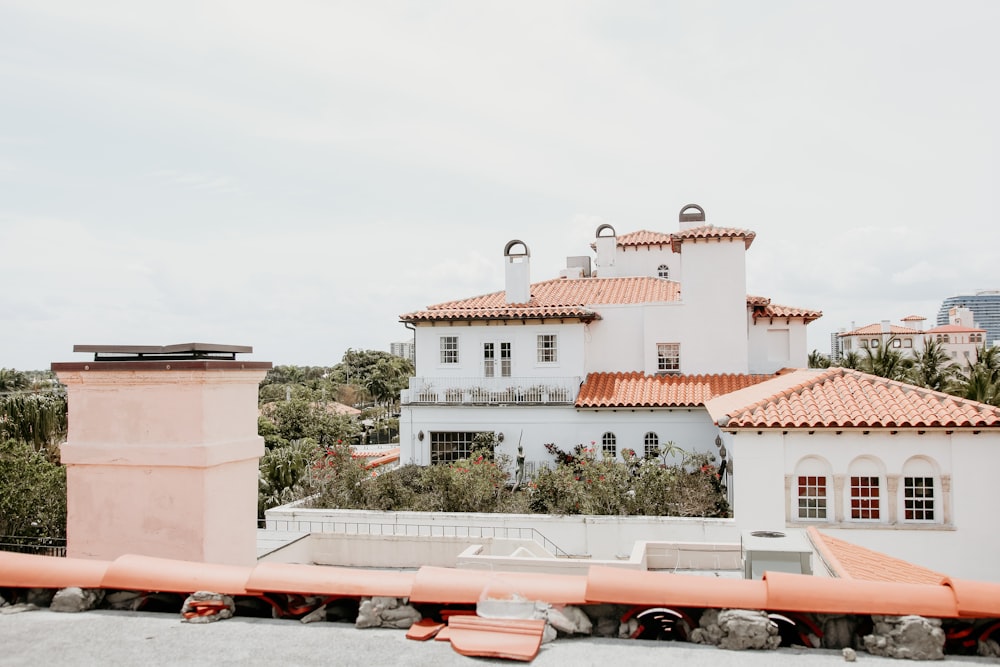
[416,320,585,379]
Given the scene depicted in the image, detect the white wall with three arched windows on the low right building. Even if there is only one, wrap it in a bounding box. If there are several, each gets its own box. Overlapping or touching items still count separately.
[726,430,1000,581]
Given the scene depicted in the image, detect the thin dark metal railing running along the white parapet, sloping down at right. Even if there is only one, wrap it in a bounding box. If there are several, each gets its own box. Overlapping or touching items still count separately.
[258,519,573,558]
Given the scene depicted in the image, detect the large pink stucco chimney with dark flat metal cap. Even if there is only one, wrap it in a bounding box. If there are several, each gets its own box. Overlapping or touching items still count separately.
[52,343,271,565]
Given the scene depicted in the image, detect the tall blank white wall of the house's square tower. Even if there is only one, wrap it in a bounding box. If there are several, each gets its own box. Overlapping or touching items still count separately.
[681,239,749,373]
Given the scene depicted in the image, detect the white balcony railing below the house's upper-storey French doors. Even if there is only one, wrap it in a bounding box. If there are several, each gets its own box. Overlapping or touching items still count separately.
[401,377,580,405]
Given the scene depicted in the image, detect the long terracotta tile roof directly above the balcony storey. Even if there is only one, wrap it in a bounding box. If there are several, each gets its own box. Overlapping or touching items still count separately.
[399,276,680,322]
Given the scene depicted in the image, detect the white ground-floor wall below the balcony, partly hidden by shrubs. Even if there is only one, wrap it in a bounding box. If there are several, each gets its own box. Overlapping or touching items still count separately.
[399,405,719,465]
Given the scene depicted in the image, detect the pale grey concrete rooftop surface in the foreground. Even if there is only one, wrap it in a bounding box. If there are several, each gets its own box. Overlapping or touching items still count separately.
[0,609,995,667]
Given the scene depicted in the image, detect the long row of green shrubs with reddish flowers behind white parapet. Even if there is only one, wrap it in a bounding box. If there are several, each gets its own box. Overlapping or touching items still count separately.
[300,445,730,517]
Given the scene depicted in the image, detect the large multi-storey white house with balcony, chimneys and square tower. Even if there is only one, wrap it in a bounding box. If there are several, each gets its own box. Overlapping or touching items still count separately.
[400,205,821,472]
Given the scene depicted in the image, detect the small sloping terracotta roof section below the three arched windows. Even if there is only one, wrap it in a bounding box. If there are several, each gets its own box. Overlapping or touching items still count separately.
[807,526,947,584]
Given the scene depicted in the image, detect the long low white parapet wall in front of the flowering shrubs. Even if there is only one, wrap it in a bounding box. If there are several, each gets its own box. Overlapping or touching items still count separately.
[265,503,740,560]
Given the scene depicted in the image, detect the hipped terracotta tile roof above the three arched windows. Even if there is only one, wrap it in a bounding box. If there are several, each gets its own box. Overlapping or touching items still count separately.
[725,368,1000,428]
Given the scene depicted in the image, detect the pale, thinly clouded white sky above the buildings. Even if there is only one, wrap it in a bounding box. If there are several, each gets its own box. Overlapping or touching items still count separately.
[0,0,1000,370]
